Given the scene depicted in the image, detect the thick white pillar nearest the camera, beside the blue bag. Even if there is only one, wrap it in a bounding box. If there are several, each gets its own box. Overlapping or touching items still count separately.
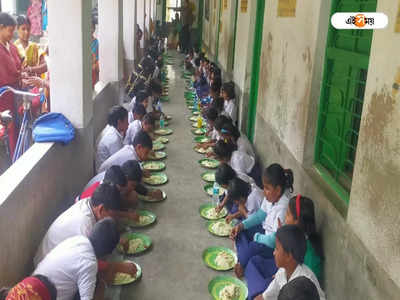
[48,0,93,128]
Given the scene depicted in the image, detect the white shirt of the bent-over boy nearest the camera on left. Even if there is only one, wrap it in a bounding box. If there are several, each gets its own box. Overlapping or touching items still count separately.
[33,235,97,300]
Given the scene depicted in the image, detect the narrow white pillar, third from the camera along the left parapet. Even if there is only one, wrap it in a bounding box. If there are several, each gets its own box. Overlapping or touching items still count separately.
[123,0,136,61]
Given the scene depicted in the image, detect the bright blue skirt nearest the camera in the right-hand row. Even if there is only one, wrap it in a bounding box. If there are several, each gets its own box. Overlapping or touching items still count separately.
[244,255,278,300]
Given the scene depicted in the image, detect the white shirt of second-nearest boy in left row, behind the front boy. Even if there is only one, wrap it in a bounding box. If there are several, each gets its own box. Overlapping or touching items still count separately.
[33,198,96,266]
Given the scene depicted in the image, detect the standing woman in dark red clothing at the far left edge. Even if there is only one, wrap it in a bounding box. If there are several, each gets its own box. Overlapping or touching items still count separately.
[0,13,21,156]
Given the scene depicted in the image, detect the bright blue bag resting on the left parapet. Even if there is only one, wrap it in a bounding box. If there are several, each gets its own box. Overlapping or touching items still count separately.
[32,113,75,144]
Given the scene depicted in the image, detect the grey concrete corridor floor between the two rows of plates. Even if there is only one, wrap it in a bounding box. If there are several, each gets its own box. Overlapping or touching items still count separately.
[106,53,233,300]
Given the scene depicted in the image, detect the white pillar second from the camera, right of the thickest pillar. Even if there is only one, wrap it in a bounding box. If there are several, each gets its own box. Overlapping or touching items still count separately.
[98,0,123,84]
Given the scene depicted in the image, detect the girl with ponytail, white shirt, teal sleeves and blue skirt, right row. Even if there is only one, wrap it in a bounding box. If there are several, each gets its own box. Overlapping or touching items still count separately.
[231,164,293,277]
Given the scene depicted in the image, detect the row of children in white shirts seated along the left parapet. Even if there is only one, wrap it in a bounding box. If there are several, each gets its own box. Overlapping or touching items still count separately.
[0,38,169,300]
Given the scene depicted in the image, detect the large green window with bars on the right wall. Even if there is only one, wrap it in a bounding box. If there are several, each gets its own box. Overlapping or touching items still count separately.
[315,0,377,201]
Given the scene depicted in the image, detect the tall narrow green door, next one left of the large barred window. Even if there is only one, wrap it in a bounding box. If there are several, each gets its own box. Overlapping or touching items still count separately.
[247,0,265,141]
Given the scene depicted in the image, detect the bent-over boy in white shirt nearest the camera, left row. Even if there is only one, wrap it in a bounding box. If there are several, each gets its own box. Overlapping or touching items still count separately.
[33,218,120,300]
